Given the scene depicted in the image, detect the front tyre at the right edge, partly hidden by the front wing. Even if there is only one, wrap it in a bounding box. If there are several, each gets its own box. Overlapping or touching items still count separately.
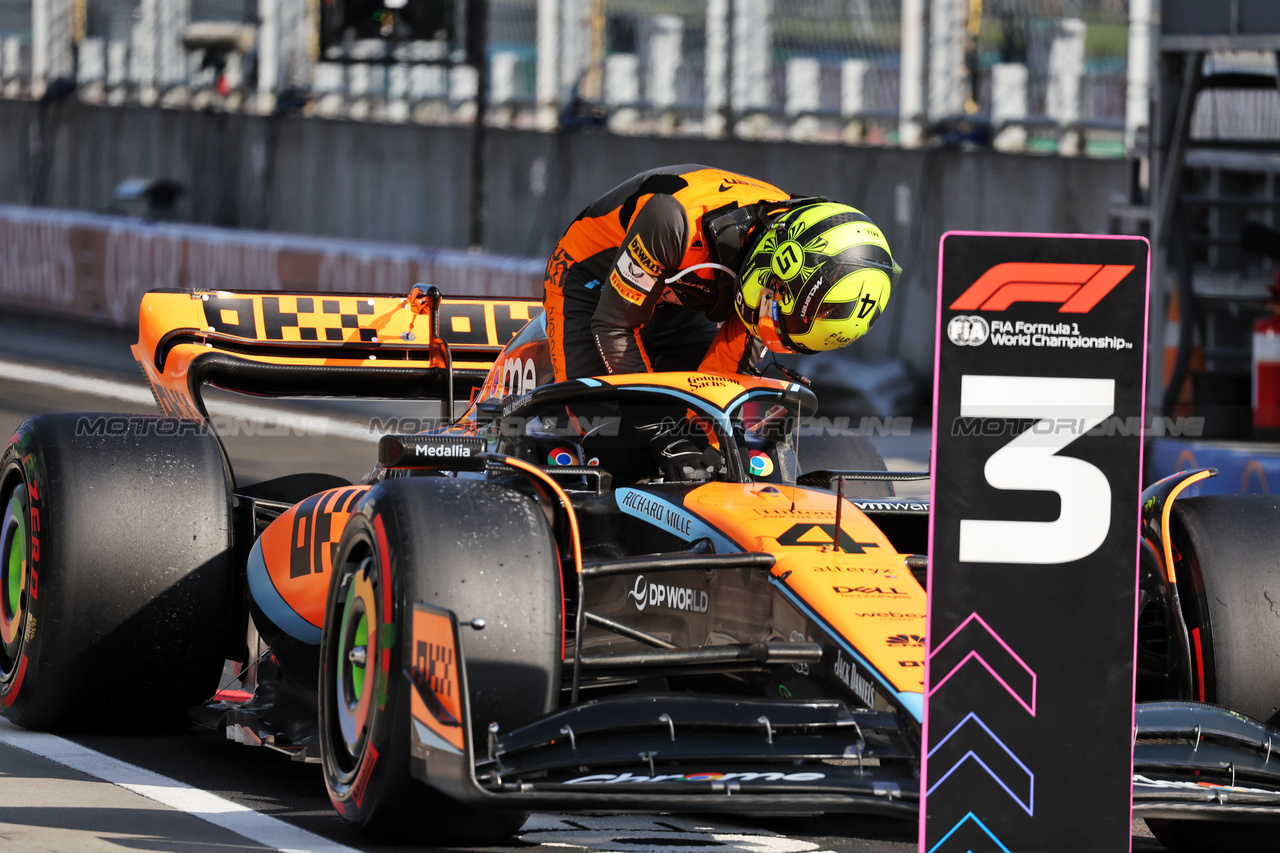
[1147,494,1280,853]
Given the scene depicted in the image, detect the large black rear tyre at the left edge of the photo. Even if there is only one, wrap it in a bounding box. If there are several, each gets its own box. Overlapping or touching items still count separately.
[0,414,232,730]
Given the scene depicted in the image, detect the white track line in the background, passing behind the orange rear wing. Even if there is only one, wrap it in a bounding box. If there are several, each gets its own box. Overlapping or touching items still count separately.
[0,359,381,443]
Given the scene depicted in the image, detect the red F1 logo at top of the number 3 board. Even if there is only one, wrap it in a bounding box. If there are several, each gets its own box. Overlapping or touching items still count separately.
[951,264,1133,314]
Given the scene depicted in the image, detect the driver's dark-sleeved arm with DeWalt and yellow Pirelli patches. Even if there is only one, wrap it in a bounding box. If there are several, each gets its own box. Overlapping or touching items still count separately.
[591,195,689,373]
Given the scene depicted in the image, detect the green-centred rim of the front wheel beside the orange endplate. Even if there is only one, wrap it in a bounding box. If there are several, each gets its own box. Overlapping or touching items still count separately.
[330,557,378,771]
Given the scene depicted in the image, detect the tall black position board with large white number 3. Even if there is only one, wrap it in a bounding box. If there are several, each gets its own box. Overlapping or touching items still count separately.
[920,232,1149,853]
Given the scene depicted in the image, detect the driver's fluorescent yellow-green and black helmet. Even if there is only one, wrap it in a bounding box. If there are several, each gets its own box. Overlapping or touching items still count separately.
[735,201,902,352]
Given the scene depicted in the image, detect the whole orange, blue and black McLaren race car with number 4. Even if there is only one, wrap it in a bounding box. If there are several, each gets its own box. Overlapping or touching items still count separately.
[0,288,1280,844]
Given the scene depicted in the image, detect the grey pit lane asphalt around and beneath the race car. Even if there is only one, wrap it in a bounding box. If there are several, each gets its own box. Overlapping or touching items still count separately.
[0,315,1164,853]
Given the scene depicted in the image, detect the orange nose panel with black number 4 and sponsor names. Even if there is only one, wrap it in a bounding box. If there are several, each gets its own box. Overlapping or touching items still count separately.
[685,483,927,693]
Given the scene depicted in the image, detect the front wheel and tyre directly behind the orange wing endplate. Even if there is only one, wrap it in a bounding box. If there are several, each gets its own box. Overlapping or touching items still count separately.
[320,478,563,844]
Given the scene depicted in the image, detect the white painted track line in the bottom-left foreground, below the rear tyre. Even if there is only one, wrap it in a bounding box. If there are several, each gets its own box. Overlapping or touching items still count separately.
[0,719,358,853]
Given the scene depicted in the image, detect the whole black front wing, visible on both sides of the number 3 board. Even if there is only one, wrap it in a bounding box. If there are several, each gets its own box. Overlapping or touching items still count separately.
[404,603,1280,821]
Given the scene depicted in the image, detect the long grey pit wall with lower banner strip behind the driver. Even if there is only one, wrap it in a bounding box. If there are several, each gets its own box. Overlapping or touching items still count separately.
[0,100,1128,377]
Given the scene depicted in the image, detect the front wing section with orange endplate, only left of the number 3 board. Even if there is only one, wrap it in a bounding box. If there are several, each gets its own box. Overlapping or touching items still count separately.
[404,603,919,817]
